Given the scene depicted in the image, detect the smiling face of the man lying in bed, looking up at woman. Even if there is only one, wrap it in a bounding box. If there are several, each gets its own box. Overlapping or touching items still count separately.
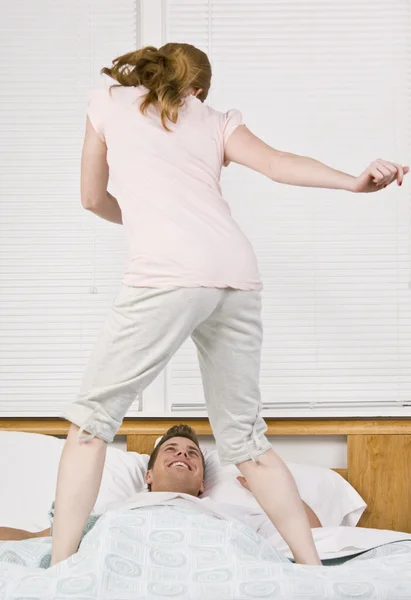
[146,437,208,496]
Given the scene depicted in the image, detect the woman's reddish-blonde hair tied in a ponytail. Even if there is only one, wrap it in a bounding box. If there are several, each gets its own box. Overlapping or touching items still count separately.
[101,43,211,131]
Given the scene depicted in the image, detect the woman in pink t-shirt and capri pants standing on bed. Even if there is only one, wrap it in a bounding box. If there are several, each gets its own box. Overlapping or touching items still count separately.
[52,43,408,564]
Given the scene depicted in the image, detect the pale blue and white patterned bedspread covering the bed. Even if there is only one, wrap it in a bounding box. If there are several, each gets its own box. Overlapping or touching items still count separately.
[0,506,411,600]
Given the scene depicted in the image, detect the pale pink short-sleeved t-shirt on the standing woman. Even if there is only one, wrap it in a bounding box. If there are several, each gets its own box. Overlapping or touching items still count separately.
[87,77,261,290]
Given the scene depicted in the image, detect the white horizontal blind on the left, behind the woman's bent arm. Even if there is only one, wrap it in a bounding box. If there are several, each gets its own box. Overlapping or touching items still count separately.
[0,0,139,416]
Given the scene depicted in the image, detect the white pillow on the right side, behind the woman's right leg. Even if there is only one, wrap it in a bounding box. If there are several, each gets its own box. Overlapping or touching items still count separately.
[202,451,367,527]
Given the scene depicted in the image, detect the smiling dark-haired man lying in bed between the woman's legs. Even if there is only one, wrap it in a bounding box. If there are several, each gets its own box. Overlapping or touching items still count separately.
[0,425,321,540]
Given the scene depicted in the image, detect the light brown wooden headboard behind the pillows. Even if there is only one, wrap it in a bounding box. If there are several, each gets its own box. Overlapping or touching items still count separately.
[0,418,411,533]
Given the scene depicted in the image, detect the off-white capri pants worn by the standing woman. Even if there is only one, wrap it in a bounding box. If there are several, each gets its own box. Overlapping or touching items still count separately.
[62,285,271,464]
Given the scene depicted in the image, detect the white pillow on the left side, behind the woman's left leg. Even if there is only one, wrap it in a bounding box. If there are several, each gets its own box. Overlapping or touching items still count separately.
[0,430,148,531]
